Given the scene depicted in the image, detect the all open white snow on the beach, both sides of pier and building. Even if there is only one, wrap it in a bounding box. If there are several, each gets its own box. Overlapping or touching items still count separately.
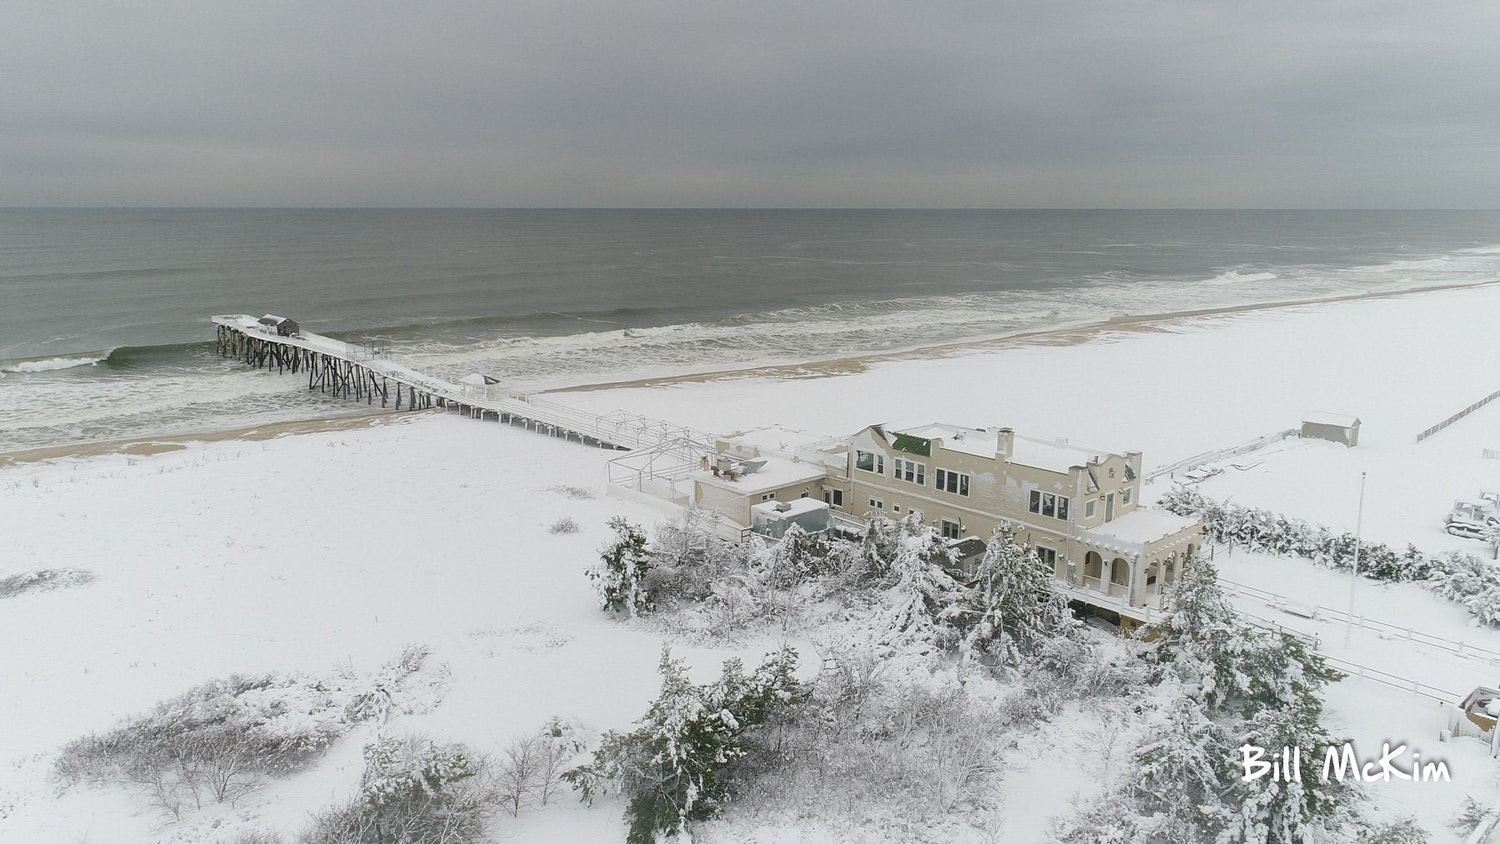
[0,285,1500,843]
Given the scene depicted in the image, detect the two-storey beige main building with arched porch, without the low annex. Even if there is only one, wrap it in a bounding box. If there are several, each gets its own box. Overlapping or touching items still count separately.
[798,424,1203,621]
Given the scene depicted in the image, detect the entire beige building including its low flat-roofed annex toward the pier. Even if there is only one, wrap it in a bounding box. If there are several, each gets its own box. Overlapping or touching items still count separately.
[617,424,1203,625]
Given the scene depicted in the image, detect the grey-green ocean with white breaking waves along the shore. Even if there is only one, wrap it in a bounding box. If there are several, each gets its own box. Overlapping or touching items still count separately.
[0,210,1500,451]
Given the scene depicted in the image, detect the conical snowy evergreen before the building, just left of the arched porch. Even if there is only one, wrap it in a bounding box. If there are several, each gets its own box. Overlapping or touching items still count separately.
[963,529,1074,666]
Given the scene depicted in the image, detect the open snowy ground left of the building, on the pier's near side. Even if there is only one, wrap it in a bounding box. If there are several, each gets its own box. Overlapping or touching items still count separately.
[0,417,798,843]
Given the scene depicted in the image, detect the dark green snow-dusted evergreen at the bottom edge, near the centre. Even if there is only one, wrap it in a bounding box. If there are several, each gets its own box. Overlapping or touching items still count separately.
[564,648,803,844]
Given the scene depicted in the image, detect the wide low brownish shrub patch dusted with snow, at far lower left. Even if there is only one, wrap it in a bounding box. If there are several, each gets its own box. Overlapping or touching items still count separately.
[54,675,348,817]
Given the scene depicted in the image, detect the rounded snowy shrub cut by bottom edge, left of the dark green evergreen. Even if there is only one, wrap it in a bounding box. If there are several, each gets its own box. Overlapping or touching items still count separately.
[300,738,492,844]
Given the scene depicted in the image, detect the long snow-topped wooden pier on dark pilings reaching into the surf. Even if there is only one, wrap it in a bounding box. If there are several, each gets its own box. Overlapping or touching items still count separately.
[213,313,711,451]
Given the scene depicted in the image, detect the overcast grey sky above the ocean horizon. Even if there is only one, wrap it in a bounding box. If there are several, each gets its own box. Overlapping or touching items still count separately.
[0,0,1500,208]
